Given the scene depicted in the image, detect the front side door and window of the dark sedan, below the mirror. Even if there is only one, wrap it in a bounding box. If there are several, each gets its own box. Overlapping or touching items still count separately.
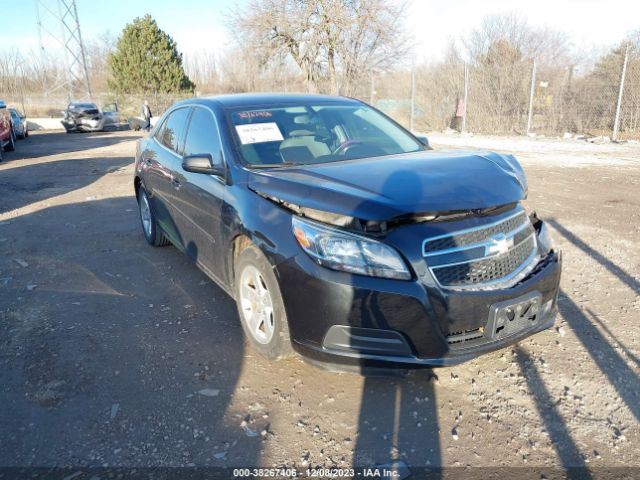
[175,106,226,279]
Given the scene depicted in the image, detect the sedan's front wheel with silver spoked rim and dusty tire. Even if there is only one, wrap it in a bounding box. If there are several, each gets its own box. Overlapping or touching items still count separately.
[234,245,293,359]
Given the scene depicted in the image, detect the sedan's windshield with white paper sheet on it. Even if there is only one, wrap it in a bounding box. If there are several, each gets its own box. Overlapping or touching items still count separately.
[231,105,424,166]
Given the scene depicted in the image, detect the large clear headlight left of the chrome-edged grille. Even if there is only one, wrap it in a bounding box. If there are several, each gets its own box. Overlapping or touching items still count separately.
[291,216,411,280]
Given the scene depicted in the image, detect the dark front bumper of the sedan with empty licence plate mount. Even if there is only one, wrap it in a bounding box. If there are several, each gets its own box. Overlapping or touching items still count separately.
[276,216,562,368]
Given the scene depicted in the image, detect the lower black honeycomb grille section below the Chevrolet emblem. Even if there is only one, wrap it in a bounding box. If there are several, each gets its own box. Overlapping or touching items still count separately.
[433,235,535,286]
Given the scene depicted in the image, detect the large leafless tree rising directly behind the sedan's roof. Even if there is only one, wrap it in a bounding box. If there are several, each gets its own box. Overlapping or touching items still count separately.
[231,0,410,94]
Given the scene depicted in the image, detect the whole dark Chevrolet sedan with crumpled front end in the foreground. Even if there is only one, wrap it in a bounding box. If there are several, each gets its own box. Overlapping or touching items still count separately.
[134,95,561,368]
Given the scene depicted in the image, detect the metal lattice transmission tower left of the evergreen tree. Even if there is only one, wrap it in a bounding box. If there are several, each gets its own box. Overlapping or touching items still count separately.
[34,0,92,99]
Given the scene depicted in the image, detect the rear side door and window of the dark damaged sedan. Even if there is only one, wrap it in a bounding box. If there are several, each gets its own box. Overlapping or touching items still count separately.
[142,107,191,245]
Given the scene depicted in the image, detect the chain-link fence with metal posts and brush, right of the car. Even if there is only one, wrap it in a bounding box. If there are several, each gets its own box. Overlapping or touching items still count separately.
[370,43,640,140]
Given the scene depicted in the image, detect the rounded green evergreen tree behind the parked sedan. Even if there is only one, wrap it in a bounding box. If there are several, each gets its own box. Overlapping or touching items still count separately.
[109,15,195,93]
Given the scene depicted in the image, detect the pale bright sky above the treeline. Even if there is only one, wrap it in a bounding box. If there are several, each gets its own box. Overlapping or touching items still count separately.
[0,0,640,60]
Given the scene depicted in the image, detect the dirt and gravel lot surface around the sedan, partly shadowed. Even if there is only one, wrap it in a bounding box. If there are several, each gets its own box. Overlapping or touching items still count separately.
[0,132,640,479]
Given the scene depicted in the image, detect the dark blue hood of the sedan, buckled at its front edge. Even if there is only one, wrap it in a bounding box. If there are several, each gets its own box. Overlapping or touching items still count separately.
[248,151,527,220]
